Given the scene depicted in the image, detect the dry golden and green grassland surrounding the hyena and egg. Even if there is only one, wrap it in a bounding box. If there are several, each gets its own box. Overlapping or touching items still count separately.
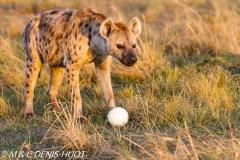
[0,0,240,159]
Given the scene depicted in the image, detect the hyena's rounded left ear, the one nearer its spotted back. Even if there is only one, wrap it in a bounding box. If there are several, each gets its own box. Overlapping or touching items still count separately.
[100,18,116,39]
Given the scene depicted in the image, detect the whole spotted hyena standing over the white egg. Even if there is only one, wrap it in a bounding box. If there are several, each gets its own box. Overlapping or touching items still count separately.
[23,8,141,118]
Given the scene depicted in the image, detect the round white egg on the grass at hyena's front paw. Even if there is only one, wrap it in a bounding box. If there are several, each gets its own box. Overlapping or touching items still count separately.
[107,107,128,127]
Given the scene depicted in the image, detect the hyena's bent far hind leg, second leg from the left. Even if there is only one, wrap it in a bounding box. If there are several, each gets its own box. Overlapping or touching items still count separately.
[47,67,65,111]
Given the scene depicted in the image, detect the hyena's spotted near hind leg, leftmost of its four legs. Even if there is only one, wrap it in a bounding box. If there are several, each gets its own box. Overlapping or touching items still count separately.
[24,52,42,119]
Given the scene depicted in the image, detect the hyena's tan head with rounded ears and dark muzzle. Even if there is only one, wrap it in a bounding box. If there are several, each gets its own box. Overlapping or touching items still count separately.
[100,17,141,66]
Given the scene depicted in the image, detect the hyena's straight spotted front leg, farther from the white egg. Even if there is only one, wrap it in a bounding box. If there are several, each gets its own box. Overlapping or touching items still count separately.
[67,66,84,122]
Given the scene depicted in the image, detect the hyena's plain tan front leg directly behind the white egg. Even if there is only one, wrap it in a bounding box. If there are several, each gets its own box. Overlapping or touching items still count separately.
[95,56,116,110]
